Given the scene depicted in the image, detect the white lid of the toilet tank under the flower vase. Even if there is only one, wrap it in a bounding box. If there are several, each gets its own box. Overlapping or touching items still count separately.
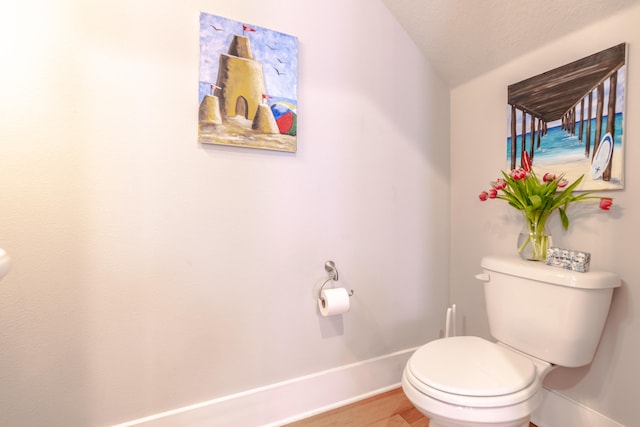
[480,255,620,289]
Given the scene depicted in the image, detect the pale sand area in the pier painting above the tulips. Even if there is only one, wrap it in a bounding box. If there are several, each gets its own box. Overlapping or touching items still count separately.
[533,147,624,191]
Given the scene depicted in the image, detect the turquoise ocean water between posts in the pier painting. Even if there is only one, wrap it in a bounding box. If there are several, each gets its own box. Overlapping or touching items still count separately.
[507,113,622,166]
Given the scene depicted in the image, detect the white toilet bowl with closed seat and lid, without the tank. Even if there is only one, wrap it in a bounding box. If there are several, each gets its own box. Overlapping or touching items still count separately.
[402,336,553,427]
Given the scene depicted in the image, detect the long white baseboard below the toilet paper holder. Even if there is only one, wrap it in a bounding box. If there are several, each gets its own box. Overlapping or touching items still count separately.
[115,348,416,427]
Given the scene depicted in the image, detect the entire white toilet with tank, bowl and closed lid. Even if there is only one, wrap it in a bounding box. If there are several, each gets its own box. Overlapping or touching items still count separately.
[402,256,620,427]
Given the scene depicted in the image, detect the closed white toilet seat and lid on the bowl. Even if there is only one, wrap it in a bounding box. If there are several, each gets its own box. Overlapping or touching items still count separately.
[405,336,539,408]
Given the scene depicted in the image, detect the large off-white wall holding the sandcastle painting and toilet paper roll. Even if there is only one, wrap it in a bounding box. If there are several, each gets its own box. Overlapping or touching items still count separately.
[0,0,450,426]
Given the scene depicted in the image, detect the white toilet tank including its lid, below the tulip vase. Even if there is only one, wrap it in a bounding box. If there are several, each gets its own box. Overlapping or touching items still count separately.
[476,256,620,367]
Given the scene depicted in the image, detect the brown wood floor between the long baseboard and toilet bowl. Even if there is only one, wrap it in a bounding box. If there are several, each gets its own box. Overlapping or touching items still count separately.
[287,389,536,427]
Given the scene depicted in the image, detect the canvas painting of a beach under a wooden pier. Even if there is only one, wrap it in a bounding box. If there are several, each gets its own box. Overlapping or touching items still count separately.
[507,43,627,191]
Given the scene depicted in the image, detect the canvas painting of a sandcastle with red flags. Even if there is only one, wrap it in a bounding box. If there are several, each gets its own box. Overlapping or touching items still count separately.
[198,13,298,152]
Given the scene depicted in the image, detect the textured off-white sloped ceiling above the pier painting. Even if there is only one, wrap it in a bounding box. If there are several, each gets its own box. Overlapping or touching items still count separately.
[383,0,640,88]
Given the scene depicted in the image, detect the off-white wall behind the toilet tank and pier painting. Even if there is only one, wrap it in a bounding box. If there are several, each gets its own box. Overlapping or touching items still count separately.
[451,6,640,426]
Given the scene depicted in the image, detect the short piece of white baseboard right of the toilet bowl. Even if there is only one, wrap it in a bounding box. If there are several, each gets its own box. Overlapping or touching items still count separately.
[531,388,624,427]
